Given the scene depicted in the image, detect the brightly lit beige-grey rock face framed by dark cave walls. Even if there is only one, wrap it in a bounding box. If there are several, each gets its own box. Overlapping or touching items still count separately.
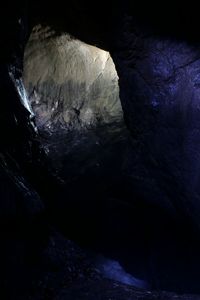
[23,25,122,131]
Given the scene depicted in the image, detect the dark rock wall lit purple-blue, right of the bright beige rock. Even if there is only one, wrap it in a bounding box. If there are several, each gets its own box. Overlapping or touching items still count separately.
[113,17,200,226]
